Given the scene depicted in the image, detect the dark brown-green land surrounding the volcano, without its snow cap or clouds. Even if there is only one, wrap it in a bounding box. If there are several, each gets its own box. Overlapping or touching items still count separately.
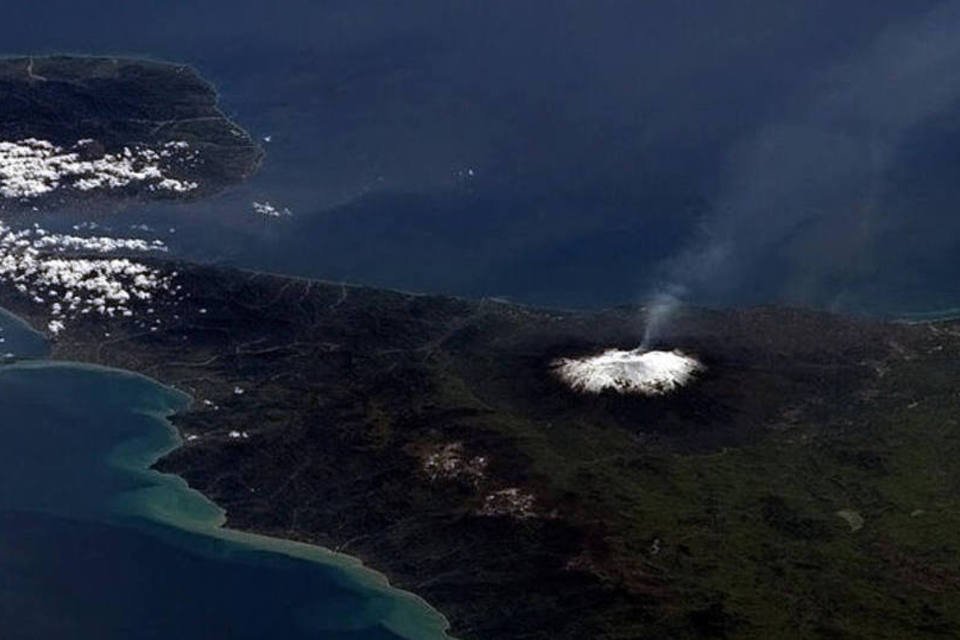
[0,265,960,640]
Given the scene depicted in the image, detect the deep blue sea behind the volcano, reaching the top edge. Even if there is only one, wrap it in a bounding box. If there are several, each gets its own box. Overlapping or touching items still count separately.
[0,0,960,314]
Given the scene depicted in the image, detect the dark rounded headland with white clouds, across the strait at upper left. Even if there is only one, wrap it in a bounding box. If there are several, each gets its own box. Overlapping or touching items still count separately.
[0,56,263,211]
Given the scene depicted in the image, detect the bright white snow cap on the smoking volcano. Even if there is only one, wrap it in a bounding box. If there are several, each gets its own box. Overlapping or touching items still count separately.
[553,349,704,396]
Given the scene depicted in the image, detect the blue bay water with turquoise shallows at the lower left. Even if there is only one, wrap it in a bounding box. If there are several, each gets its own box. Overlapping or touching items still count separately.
[0,312,445,640]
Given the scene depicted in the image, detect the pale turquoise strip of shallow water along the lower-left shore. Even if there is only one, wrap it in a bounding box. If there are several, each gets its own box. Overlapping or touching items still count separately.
[0,318,455,640]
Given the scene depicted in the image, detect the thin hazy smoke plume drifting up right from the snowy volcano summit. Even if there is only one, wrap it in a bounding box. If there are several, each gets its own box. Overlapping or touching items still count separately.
[645,0,960,342]
